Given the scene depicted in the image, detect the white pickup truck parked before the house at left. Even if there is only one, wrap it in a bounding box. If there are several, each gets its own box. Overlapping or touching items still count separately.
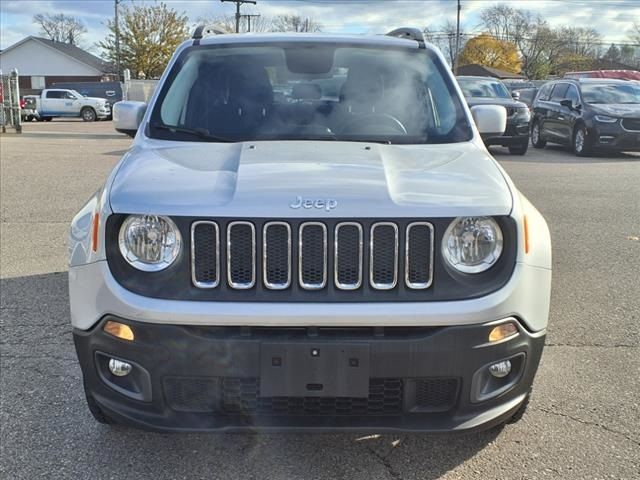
[31,88,111,122]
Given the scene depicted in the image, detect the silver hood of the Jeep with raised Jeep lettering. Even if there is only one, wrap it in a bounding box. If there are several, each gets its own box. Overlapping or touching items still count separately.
[110,140,512,218]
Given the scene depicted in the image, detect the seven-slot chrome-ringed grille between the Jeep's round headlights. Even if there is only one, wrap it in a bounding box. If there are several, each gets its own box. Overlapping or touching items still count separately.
[191,221,434,291]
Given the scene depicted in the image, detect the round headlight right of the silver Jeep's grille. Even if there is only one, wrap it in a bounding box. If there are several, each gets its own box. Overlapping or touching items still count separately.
[442,217,502,273]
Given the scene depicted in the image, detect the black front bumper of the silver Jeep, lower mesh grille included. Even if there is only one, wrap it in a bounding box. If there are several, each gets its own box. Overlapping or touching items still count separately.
[74,317,545,432]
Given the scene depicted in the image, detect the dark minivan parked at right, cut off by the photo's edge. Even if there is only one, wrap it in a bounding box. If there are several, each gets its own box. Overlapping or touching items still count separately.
[531,79,640,156]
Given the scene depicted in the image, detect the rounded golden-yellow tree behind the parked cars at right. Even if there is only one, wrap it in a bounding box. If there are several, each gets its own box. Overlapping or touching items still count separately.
[459,33,521,73]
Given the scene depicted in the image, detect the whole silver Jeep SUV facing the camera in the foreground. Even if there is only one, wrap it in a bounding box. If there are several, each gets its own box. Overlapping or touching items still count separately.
[69,28,551,432]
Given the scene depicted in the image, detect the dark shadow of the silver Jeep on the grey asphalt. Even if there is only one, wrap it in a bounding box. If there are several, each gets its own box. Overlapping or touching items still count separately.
[0,272,500,480]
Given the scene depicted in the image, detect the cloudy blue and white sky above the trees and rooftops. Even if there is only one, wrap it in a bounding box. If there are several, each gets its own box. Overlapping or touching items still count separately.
[0,0,640,53]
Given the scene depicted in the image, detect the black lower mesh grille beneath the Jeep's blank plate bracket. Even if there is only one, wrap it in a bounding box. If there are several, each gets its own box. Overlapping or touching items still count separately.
[164,377,459,416]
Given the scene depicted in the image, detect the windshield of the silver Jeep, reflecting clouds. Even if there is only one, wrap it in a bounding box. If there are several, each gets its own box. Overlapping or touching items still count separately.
[149,43,472,143]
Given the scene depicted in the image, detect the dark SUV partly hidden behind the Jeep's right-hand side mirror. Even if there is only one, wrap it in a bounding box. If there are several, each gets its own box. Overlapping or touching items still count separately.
[456,76,531,155]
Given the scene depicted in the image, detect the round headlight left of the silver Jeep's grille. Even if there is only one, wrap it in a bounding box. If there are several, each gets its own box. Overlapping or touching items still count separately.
[118,215,182,272]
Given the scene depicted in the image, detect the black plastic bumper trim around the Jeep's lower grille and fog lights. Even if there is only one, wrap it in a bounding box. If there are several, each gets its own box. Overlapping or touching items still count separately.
[73,316,545,432]
